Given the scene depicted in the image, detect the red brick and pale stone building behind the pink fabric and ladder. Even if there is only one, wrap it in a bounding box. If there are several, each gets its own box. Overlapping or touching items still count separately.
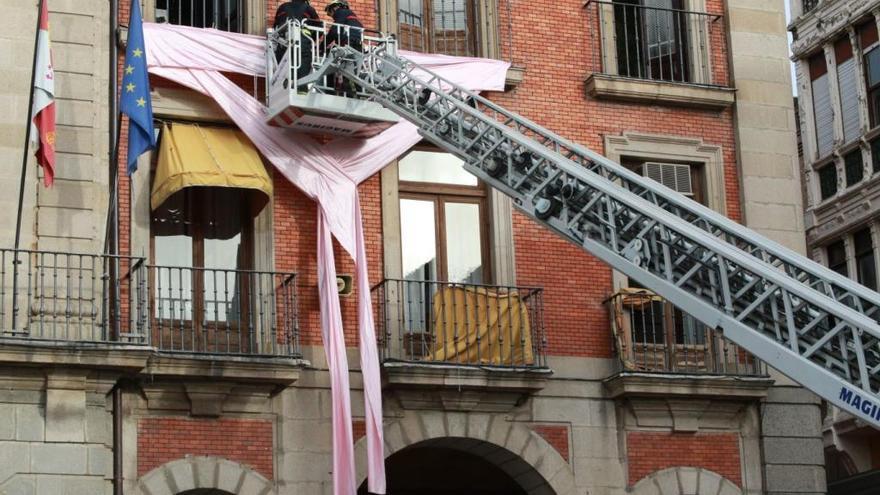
[0,0,825,495]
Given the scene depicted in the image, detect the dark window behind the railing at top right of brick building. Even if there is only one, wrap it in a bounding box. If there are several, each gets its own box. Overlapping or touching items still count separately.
[614,0,691,82]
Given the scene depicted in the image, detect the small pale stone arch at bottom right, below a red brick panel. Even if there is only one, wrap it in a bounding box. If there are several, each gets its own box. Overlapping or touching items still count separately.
[632,467,743,495]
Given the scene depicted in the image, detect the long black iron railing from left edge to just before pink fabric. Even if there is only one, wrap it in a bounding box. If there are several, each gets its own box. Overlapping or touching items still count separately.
[0,249,299,357]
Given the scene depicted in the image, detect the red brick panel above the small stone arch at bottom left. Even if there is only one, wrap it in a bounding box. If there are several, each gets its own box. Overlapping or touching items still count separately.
[137,417,274,479]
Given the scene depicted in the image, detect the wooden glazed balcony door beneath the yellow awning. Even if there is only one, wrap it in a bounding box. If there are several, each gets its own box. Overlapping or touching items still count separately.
[150,187,254,353]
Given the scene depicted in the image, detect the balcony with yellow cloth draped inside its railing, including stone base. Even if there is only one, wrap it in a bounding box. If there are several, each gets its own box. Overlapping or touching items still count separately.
[373,279,551,412]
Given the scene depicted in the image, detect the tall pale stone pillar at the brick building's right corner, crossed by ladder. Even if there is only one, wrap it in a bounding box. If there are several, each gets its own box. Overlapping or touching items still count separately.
[727,0,825,495]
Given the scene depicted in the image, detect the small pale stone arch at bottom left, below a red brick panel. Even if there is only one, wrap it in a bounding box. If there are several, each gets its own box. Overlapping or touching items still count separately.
[138,456,277,495]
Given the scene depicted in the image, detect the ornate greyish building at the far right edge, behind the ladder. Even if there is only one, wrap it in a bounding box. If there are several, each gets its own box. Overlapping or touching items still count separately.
[789,0,880,494]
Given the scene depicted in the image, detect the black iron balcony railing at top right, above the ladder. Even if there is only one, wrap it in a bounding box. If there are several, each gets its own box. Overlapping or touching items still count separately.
[586,0,726,86]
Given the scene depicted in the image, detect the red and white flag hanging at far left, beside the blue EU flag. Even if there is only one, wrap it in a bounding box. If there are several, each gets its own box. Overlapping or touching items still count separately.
[31,0,55,187]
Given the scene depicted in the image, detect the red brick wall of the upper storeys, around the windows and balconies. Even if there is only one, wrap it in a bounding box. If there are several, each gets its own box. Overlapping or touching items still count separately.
[120,0,740,357]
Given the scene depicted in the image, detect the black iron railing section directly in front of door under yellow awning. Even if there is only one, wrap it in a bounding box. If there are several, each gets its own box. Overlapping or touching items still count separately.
[149,265,299,356]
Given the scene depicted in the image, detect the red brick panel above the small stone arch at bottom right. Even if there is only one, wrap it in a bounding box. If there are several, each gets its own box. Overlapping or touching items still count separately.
[626,431,742,486]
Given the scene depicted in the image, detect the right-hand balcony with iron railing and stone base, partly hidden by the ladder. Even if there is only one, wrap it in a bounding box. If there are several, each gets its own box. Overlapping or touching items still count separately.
[605,288,773,404]
